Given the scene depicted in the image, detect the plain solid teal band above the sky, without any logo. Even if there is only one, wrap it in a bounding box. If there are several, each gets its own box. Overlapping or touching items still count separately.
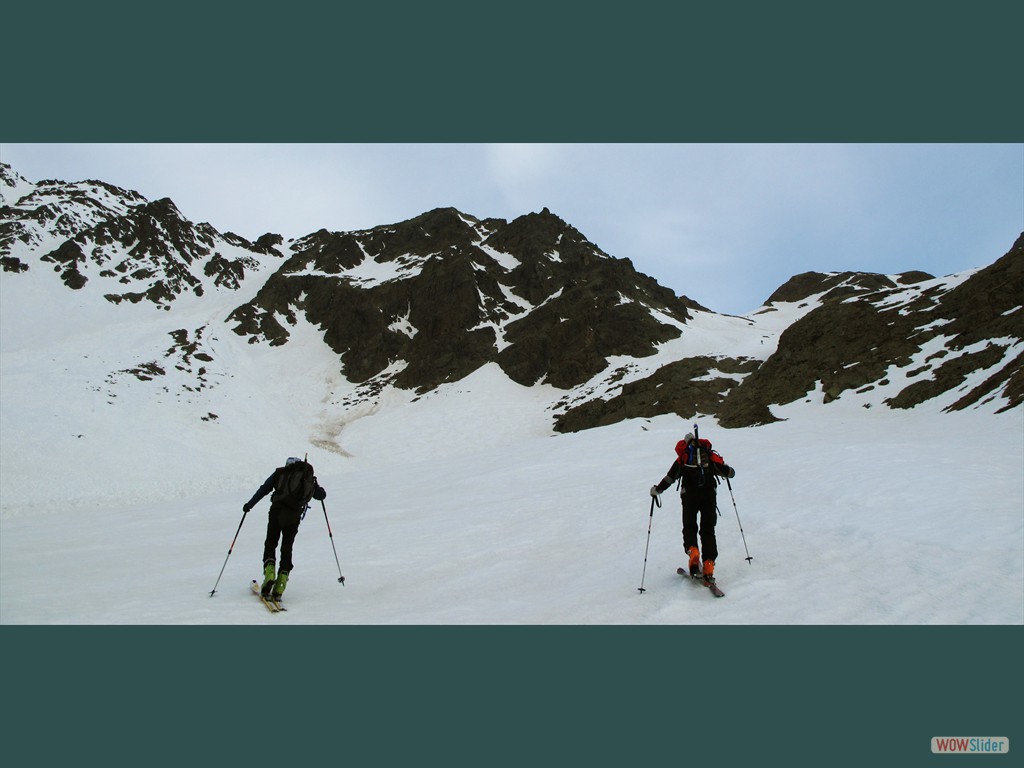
[6,0,1024,142]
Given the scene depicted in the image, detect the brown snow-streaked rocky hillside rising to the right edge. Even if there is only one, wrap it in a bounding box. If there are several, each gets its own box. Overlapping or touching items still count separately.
[718,236,1024,427]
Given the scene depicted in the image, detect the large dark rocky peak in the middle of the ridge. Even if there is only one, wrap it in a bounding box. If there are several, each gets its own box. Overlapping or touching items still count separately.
[231,208,688,391]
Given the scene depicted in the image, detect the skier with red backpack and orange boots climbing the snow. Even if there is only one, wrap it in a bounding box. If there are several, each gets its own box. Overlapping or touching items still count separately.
[650,433,736,584]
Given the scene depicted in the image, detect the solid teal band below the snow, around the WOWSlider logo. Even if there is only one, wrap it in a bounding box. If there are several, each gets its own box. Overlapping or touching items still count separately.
[0,626,1021,766]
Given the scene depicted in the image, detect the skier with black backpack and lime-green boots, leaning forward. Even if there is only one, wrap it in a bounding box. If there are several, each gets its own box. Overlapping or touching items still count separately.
[242,457,327,601]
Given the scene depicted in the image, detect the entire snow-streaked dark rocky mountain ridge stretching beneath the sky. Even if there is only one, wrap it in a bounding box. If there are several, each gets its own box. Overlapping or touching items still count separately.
[0,164,1024,450]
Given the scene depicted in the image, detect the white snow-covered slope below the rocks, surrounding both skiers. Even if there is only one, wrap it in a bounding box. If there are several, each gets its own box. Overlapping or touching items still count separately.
[0,167,1024,625]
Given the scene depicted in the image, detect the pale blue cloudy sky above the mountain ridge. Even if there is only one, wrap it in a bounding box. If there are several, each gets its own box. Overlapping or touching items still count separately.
[0,143,1024,314]
